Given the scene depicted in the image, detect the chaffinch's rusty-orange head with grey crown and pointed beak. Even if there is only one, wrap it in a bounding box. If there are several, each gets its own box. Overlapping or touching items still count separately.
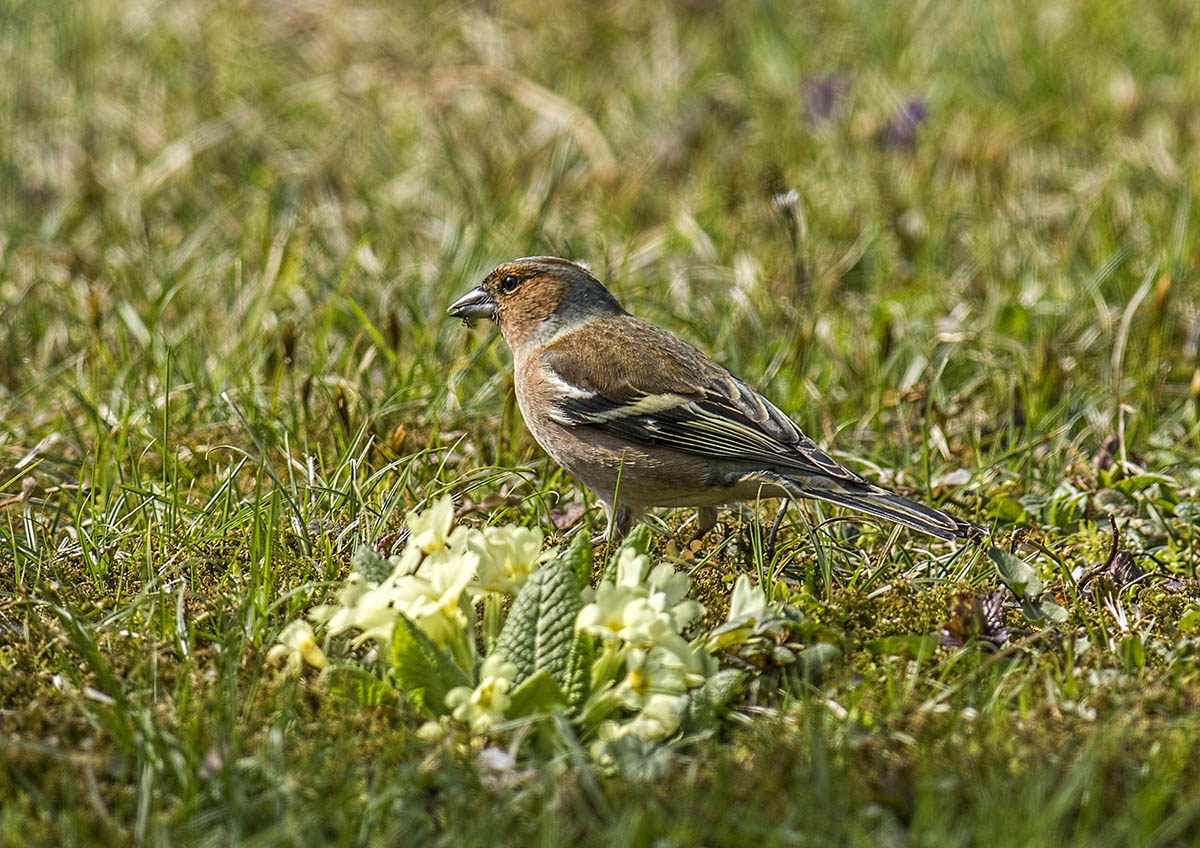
[449,257,624,349]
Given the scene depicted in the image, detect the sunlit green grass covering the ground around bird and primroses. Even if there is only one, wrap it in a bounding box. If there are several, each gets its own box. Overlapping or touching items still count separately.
[0,0,1200,846]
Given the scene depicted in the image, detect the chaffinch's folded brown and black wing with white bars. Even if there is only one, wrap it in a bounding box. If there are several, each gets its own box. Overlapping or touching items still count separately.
[540,315,863,482]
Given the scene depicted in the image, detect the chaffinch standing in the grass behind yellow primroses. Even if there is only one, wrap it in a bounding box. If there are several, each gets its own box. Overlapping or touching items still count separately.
[449,257,983,540]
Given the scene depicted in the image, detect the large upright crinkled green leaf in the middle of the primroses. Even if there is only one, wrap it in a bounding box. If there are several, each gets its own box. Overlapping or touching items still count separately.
[496,560,583,691]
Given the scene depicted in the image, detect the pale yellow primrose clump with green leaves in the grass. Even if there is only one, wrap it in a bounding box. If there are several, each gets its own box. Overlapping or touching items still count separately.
[271,497,767,756]
